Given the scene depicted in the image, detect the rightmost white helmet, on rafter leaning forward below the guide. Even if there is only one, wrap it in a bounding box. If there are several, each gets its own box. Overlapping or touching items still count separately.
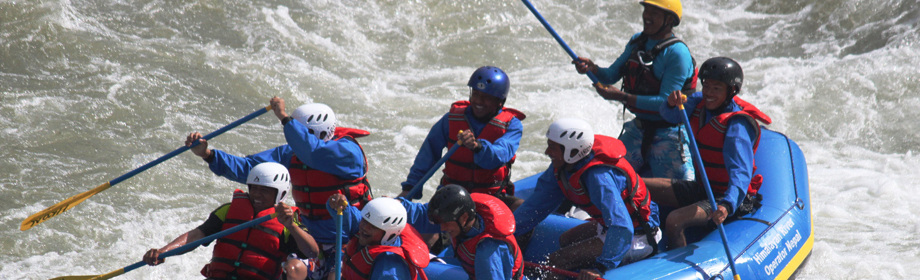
[546,118,594,163]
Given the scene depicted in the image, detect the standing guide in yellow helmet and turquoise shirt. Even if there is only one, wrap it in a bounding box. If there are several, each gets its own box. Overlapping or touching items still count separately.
[573,0,696,179]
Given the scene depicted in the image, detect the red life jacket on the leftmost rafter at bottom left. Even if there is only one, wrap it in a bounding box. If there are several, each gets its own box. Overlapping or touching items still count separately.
[201,189,287,280]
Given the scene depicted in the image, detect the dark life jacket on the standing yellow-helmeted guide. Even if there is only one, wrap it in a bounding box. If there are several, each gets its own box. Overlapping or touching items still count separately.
[620,34,699,115]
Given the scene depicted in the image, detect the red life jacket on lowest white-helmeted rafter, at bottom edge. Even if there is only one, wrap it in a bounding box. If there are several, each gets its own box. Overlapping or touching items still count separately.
[342,224,429,280]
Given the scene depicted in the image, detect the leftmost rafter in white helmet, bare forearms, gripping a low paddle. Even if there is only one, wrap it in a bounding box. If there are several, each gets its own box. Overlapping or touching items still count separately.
[143,162,319,280]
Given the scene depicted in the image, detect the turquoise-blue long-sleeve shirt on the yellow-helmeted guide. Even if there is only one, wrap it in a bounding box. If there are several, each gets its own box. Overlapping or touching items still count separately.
[597,32,693,121]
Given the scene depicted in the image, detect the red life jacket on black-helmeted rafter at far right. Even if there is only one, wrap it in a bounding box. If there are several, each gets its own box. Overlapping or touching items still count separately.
[689,96,772,195]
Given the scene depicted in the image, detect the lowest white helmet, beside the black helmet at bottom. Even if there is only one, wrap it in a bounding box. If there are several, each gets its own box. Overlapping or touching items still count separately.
[361,197,406,246]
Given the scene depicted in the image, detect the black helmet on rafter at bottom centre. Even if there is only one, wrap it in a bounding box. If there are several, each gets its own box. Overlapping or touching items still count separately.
[428,184,476,225]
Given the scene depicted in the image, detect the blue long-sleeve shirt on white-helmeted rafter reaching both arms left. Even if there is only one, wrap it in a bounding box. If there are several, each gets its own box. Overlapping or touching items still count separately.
[208,119,365,244]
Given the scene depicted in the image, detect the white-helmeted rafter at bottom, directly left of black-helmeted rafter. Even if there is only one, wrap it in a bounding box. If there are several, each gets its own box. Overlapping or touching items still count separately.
[327,194,429,280]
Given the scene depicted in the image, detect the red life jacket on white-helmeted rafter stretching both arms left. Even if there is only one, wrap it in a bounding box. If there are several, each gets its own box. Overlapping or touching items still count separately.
[288,127,371,220]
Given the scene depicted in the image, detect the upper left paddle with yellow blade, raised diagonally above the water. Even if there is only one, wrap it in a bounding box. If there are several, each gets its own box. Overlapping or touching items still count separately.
[19,105,272,231]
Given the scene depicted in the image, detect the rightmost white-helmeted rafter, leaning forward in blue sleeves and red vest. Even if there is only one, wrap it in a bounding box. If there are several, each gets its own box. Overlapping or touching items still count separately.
[514,118,661,279]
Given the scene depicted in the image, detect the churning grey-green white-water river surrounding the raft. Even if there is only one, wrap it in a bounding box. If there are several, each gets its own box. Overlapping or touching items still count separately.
[0,0,920,279]
